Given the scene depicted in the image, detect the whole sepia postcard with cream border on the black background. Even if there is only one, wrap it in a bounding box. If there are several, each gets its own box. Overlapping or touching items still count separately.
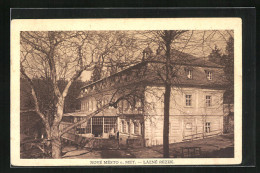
[11,19,242,166]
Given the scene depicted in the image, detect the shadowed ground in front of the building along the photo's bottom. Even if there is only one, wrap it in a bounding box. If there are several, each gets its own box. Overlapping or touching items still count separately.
[21,134,234,159]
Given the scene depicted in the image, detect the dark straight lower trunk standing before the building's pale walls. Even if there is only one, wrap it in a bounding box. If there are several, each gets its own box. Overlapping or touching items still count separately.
[163,84,171,158]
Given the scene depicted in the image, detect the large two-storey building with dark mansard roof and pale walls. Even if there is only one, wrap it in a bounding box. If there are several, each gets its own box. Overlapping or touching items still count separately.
[63,51,226,146]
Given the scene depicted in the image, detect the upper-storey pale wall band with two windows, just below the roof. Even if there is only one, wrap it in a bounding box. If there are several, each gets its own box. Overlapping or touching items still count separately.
[145,87,224,115]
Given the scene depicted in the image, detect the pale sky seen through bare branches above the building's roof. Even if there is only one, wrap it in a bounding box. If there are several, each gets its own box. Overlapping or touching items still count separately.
[21,30,234,81]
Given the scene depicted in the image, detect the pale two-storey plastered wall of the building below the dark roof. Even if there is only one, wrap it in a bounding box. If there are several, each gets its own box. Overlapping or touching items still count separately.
[145,87,224,146]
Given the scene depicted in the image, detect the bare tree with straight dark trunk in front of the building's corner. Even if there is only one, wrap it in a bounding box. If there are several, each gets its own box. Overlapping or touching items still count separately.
[139,30,232,158]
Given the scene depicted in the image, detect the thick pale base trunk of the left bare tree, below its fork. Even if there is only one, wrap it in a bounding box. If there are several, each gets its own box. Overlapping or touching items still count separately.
[51,126,61,159]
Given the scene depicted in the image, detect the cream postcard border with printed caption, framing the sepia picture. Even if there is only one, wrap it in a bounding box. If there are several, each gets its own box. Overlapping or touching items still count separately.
[10,18,242,166]
